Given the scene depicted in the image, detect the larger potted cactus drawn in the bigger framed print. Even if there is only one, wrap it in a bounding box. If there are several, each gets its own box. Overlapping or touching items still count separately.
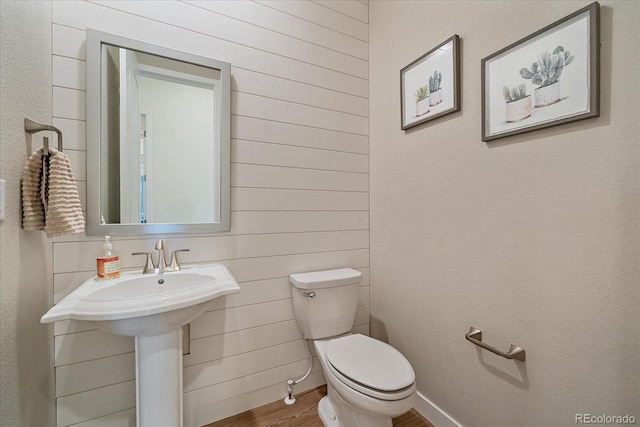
[520,46,575,107]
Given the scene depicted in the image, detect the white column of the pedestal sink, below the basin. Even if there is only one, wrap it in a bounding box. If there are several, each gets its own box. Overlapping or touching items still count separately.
[135,328,182,427]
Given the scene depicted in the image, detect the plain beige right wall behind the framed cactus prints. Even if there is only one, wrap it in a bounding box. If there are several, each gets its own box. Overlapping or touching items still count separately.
[369,1,640,426]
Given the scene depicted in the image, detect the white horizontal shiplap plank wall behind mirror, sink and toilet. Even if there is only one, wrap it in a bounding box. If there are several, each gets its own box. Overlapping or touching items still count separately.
[52,0,369,426]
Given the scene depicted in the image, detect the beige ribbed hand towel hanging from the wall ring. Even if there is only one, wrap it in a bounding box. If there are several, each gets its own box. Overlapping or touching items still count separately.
[22,148,84,237]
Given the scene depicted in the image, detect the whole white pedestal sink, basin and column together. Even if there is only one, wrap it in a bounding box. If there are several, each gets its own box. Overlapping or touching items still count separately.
[40,264,240,427]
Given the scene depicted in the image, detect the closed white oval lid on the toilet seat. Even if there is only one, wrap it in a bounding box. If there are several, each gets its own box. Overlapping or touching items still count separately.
[326,334,415,392]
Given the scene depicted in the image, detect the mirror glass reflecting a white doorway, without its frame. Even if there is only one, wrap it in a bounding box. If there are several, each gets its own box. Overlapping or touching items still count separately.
[100,44,220,224]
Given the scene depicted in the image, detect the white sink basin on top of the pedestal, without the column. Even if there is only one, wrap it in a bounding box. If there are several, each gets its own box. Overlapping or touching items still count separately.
[40,264,240,336]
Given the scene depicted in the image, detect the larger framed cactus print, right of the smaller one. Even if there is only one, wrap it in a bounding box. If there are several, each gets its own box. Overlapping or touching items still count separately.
[482,2,600,141]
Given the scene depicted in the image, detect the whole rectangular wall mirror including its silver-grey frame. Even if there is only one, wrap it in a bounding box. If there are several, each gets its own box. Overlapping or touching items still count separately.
[87,29,231,236]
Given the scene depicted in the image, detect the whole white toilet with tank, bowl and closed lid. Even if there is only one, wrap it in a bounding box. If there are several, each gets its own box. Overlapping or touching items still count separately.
[289,268,416,427]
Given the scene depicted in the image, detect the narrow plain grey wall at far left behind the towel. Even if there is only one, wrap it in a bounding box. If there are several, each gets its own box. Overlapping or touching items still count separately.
[0,1,57,427]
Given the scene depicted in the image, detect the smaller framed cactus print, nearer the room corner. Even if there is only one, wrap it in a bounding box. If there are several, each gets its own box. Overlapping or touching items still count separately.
[400,34,460,130]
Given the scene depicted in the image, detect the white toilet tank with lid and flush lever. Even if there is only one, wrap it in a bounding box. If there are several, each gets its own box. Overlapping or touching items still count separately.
[289,268,362,339]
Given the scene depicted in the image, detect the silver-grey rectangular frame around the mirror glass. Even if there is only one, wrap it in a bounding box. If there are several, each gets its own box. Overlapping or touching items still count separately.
[86,28,231,236]
